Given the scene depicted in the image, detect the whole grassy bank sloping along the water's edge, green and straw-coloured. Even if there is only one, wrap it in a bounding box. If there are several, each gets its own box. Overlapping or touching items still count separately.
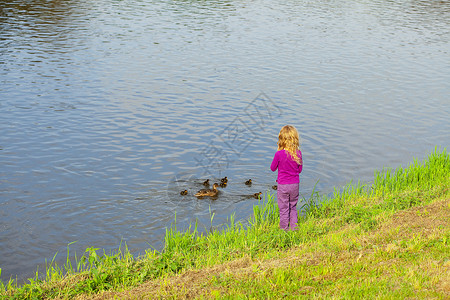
[0,150,450,299]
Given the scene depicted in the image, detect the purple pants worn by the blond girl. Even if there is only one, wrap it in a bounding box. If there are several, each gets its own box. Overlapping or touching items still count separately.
[277,183,299,230]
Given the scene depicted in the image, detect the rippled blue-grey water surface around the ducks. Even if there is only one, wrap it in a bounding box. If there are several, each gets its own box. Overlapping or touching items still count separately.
[0,0,450,280]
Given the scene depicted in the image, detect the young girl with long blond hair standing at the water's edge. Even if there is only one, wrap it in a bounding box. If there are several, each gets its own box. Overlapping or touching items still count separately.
[270,125,303,230]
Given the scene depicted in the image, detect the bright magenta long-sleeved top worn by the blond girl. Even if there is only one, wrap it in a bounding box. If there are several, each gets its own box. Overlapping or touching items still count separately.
[270,149,303,184]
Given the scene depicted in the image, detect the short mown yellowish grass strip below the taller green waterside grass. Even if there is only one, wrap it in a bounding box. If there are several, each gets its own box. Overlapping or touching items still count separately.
[93,199,450,299]
